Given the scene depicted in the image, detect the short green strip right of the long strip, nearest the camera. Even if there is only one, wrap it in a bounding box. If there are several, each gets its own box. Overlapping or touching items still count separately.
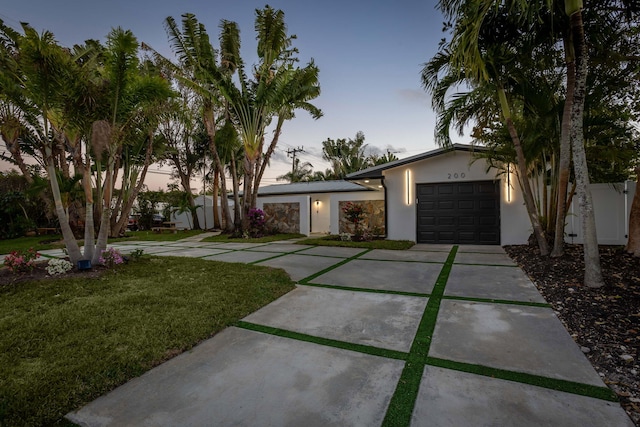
[427,357,618,402]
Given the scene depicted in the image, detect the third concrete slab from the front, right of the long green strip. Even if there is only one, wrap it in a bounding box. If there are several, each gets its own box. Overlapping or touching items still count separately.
[444,264,546,303]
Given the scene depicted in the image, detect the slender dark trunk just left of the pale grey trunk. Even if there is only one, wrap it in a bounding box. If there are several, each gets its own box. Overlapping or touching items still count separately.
[551,36,576,258]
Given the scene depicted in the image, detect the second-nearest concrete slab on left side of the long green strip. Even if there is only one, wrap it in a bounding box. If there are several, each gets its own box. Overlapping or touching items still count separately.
[244,286,427,352]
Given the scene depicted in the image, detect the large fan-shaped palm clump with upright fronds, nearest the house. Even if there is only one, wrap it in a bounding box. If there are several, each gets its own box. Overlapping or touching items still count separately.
[155,6,321,234]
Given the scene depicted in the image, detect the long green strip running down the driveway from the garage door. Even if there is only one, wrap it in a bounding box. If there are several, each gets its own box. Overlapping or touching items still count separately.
[382,246,458,427]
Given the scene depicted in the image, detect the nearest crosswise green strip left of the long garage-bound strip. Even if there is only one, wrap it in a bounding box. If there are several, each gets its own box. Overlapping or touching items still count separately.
[234,320,407,360]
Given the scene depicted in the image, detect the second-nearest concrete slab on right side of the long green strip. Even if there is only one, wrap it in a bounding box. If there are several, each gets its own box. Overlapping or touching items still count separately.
[429,300,604,386]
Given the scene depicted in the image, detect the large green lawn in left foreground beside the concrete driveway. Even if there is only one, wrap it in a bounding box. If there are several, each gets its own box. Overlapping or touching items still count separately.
[0,257,294,425]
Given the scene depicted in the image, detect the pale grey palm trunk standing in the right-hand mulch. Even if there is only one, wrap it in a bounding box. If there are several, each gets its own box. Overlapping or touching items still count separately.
[570,9,604,288]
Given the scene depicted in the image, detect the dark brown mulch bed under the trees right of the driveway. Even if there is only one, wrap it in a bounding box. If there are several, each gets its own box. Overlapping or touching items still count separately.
[505,245,640,426]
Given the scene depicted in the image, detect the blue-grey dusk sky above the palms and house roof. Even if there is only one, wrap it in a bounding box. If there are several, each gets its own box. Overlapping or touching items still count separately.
[0,0,460,190]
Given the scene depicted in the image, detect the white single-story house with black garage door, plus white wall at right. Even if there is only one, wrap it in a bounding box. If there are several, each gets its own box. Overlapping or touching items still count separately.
[258,144,636,245]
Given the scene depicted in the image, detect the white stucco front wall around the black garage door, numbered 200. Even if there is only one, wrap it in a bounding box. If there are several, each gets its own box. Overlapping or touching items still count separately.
[384,151,531,245]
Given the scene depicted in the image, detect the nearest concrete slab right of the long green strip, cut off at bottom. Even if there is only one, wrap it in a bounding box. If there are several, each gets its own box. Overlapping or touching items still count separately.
[411,366,633,427]
